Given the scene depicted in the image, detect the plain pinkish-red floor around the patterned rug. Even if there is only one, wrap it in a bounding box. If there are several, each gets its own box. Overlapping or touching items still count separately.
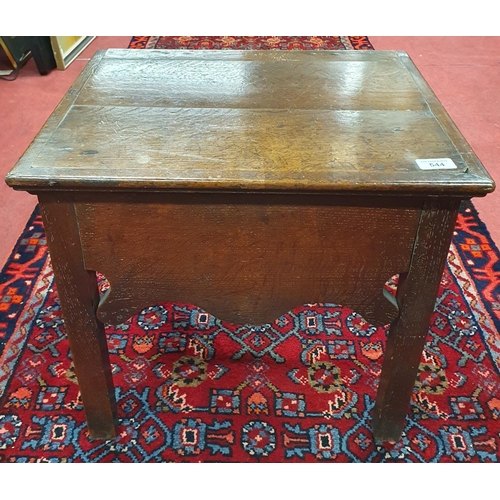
[0,36,500,269]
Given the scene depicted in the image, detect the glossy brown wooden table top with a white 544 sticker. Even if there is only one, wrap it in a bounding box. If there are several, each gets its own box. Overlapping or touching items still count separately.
[6,49,494,196]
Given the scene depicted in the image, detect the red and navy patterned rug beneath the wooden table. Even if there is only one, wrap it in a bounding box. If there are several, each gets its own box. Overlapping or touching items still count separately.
[0,37,500,462]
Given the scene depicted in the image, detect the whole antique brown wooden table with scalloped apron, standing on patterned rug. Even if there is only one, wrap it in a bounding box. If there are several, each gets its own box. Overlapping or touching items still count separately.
[7,50,494,442]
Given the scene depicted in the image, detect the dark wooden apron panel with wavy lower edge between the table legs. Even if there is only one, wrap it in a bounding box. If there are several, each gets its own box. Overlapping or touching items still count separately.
[76,194,422,324]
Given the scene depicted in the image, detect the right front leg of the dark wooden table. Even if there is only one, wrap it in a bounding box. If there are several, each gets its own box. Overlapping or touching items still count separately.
[372,199,459,443]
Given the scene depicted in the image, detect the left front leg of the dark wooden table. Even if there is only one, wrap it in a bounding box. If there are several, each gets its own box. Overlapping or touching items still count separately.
[38,194,116,439]
